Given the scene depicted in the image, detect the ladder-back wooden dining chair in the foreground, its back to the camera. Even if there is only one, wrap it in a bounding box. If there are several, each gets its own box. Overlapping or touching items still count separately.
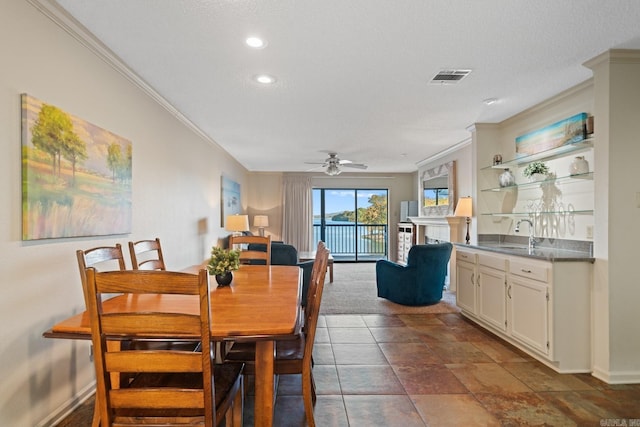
[86,268,244,427]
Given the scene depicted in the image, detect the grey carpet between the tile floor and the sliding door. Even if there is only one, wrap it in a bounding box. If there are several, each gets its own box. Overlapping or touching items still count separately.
[320,263,459,314]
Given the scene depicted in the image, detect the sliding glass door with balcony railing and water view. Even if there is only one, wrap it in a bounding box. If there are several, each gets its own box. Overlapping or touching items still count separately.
[313,188,388,261]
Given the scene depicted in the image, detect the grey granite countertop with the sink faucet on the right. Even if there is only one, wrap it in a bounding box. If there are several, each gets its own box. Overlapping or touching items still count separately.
[455,238,595,262]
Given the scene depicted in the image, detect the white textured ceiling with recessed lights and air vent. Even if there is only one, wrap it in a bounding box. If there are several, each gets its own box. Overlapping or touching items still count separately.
[51,0,640,173]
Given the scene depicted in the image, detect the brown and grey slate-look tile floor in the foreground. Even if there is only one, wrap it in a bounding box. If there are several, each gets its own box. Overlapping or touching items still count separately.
[60,313,640,427]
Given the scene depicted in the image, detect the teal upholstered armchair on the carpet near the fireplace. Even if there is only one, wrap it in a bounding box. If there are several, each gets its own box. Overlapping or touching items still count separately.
[376,242,453,305]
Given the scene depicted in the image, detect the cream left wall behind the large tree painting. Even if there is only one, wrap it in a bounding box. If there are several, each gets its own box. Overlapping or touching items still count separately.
[0,0,247,426]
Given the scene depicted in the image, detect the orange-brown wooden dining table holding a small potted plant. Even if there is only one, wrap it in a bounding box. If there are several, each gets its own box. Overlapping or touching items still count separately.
[43,263,302,426]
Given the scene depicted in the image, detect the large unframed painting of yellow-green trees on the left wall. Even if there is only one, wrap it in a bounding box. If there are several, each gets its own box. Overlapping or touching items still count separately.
[21,94,132,240]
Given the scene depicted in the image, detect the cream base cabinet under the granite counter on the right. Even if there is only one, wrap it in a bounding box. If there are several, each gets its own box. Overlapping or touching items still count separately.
[456,248,592,373]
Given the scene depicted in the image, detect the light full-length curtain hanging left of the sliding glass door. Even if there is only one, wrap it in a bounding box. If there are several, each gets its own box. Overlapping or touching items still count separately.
[282,175,313,252]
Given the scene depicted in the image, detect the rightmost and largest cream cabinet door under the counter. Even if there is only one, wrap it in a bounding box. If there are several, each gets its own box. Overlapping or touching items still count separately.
[507,275,549,355]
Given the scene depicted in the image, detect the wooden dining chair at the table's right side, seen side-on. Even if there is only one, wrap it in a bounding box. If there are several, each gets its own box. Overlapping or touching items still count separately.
[225,242,329,427]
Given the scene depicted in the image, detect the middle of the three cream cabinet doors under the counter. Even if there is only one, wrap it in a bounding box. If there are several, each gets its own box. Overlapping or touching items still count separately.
[478,262,507,331]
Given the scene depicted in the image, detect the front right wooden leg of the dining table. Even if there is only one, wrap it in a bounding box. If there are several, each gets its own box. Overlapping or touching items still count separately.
[254,340,275,427]
